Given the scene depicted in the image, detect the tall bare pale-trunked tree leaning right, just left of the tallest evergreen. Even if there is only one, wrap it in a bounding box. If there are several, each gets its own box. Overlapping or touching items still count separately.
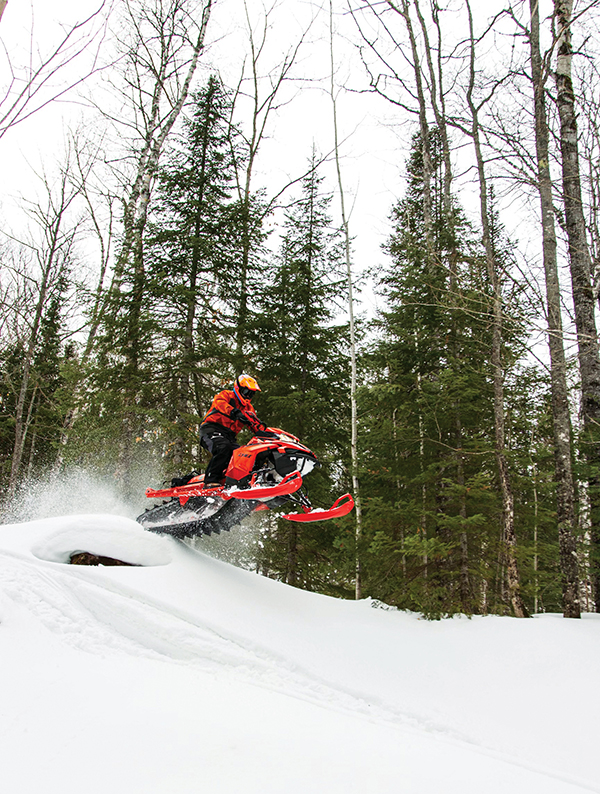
[91,0,213,479]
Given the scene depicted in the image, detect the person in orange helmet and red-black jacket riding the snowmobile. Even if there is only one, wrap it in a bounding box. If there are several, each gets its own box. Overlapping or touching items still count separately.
[200,374,271,488]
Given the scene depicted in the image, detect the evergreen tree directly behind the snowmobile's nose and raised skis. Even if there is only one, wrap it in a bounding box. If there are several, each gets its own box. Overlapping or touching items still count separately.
[254,157,352,592]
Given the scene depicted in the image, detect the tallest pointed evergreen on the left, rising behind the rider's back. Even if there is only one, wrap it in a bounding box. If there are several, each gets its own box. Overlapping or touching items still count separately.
[147,76,236,466]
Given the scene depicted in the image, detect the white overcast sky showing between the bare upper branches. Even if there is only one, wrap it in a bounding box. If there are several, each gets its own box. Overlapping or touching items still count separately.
[0,0,584,336]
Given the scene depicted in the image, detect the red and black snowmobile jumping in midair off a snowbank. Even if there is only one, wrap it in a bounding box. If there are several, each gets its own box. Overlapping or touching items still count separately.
[136,427,354,539]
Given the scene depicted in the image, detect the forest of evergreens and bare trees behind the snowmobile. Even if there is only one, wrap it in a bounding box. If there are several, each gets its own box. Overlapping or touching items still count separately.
[0,0,600,619]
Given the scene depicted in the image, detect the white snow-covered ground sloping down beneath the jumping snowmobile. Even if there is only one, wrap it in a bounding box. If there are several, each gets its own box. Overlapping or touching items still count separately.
[0,515,600,794]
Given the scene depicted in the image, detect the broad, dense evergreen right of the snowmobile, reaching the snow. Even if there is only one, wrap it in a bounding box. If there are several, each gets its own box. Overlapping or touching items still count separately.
[361,130,528,616]
